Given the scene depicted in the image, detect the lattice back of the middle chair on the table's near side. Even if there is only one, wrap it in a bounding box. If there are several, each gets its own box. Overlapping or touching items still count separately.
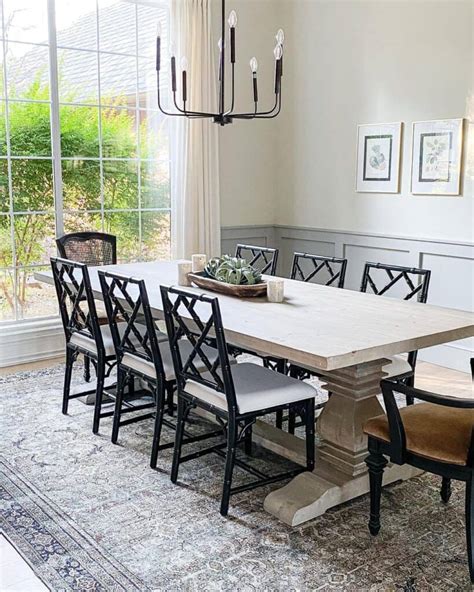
[98,271,164,377]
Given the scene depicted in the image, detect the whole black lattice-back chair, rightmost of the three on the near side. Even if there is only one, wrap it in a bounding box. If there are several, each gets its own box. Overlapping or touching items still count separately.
[161,286,315,516]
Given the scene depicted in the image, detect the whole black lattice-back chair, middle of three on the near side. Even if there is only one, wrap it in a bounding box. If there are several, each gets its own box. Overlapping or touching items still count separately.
[99,271,226,469]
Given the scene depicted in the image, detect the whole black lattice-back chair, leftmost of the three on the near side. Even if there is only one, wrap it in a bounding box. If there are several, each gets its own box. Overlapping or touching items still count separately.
[51,257,115,434]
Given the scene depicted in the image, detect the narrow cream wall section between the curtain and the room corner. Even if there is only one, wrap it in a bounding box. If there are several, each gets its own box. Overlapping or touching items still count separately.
[213,0,281,226]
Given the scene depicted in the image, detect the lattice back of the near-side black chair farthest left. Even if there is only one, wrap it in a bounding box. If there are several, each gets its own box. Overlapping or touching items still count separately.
[51,257,103,351]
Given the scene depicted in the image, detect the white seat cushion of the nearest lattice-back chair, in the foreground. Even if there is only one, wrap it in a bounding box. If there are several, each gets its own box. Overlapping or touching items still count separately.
[184,363,316,413]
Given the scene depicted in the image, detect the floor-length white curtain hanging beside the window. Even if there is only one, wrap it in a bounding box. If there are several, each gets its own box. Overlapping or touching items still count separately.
[171,0,221,258]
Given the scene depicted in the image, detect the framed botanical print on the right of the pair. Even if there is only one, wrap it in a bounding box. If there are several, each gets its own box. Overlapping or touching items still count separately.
[411,119,464,195]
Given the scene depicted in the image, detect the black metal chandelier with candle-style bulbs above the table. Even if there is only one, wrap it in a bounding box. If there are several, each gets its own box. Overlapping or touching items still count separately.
[156,0,285,125]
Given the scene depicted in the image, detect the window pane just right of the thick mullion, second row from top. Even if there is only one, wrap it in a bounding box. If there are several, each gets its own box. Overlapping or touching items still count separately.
[58,49,99,105]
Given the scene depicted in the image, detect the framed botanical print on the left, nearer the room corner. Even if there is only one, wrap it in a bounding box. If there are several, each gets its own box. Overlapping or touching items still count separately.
[356,122,402,193]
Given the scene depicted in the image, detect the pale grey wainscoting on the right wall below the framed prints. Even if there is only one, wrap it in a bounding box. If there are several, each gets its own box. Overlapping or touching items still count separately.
[274,226,474,372]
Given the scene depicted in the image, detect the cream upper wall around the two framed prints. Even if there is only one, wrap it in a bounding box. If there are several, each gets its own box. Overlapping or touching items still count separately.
[275,0,474,241]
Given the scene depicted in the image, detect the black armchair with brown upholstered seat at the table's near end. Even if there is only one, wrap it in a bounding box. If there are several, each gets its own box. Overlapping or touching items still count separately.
[364,380,474,583]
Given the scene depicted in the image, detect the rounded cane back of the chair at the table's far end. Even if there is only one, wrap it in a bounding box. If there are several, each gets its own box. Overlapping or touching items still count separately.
[56,232,117,266]
